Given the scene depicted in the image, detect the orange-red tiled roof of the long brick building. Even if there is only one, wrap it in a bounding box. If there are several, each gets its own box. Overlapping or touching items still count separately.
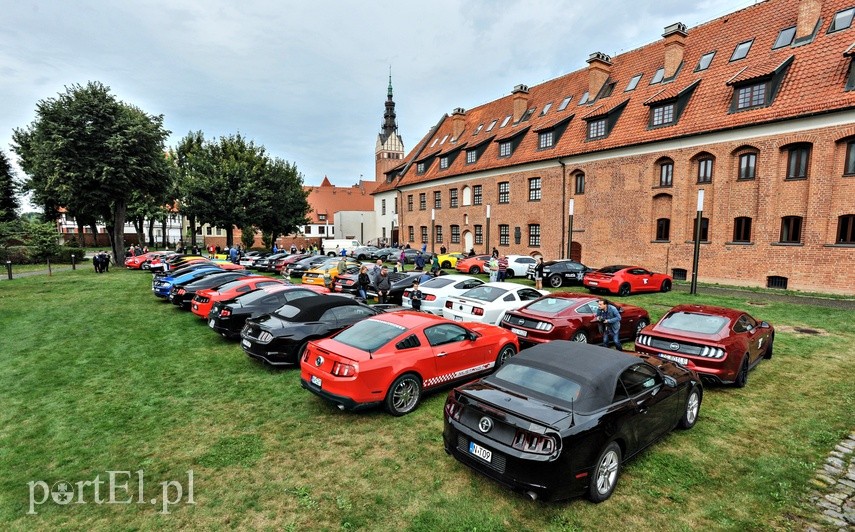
[384,0,855,192]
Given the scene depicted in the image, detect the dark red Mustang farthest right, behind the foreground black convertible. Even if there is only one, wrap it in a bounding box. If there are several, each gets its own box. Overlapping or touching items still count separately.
[635,305,775,388]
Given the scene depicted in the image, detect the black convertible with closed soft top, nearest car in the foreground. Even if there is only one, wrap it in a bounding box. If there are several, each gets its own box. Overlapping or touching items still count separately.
[443,340,703,502]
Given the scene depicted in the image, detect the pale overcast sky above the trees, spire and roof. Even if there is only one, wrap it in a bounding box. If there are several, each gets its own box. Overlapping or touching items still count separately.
[0,0,755,202]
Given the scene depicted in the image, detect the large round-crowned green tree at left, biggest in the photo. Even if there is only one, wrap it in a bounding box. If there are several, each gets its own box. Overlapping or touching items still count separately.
[12,82,169,262]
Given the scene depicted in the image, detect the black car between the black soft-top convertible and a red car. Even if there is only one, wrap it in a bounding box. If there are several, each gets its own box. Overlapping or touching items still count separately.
[208,285,321,338]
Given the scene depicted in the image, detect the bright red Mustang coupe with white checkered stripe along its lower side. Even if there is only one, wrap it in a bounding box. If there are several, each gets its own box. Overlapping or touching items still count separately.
[300,311,519,416]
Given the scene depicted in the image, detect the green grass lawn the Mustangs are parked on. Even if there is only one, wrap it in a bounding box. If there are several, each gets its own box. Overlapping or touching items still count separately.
[0,267,855,531]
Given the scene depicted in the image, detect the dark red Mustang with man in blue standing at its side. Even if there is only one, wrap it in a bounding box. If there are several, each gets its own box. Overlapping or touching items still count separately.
[500,292,650,344]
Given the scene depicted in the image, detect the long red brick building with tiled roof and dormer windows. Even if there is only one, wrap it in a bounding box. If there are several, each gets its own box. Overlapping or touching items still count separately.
[375,0,855,293]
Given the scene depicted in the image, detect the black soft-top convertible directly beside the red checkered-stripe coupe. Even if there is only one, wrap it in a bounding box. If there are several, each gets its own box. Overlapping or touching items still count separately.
[240,296,401,366]
